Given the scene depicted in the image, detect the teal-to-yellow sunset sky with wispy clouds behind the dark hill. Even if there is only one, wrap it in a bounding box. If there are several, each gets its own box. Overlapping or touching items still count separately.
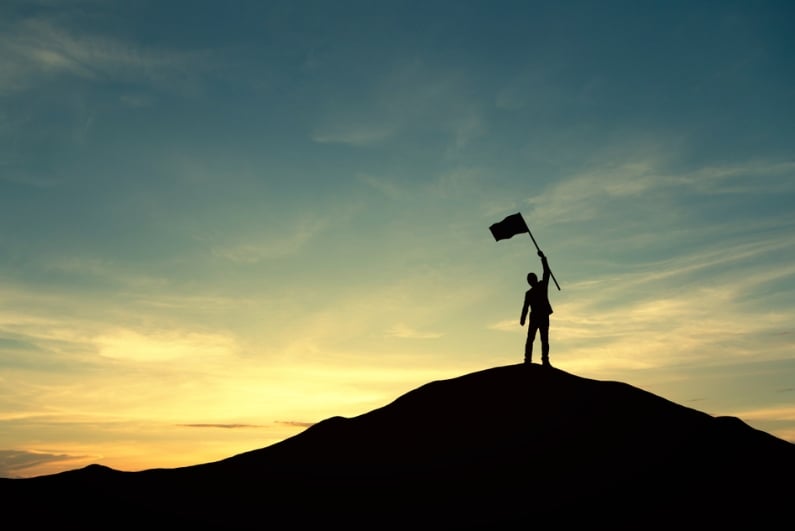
[0,0,795,477]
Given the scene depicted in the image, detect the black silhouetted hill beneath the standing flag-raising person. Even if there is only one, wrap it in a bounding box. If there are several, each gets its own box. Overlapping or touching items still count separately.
[0,365,795,529]
